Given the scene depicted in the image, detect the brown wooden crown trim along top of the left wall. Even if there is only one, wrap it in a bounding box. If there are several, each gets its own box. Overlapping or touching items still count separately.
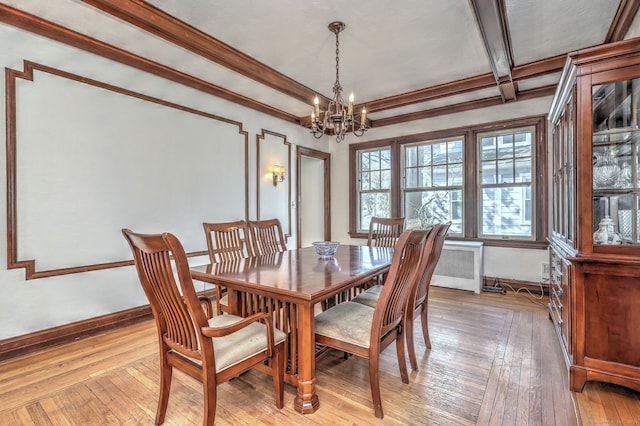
[0,4,300,124]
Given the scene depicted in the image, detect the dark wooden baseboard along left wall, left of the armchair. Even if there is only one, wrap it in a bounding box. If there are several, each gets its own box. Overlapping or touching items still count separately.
[0,305,153,362]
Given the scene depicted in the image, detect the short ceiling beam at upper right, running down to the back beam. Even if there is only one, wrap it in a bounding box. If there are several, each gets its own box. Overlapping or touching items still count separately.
[469,0,517,102]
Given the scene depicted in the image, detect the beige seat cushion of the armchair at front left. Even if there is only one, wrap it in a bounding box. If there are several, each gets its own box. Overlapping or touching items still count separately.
[188,314,287,372]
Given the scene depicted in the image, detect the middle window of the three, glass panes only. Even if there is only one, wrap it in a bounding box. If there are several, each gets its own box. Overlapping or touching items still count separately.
[402,138,464,234]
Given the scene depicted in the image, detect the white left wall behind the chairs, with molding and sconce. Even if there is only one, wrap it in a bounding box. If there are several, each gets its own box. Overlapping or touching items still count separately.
[0,24,328,340]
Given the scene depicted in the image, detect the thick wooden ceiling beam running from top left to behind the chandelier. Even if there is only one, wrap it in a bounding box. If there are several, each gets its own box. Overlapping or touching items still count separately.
[82,0,329,103]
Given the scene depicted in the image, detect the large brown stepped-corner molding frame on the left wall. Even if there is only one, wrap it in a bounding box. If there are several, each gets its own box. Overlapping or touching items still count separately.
[5,61,249,279]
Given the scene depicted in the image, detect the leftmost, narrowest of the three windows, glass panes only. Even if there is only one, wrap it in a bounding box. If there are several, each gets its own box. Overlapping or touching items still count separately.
[357,148,391,229]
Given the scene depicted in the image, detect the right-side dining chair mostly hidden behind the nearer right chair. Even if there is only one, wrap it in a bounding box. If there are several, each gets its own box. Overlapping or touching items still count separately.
[405,222,451,371]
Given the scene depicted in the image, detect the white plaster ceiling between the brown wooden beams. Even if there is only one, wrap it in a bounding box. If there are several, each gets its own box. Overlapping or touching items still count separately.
[0,0,632,126]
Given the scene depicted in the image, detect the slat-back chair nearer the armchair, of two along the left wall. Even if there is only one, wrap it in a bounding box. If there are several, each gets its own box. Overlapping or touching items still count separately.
[202,220,253,315]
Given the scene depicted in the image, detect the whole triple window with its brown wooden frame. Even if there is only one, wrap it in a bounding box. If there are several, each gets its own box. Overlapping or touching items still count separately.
[349,116,547,248]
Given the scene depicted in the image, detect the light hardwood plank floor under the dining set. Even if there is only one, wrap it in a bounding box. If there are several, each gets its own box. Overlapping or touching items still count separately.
[0,287,640,426]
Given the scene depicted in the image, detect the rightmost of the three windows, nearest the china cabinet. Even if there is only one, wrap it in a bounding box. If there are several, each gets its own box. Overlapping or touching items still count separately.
[478,128,534,239]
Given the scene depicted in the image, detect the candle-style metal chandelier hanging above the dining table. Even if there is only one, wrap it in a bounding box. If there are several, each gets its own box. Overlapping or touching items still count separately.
[311,21,368,143]
